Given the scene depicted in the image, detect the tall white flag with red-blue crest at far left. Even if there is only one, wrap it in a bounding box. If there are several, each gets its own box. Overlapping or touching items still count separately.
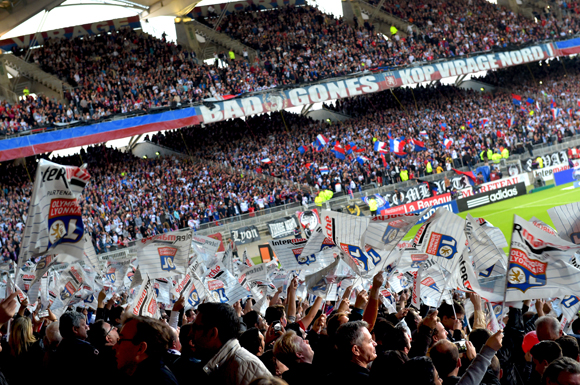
[16,159,90,272]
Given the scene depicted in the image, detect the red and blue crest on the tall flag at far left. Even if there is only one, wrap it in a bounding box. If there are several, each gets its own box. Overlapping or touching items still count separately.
[48,198,84,247]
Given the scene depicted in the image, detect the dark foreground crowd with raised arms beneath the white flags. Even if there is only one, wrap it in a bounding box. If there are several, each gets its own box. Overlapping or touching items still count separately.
[0,273,580,385]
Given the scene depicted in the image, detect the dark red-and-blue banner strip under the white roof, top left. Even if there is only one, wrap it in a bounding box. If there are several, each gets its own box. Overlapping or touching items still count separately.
[0,16,141,51]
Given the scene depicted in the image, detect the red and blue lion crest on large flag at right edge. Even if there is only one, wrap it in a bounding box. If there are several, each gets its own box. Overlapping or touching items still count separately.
[507,249,548,293]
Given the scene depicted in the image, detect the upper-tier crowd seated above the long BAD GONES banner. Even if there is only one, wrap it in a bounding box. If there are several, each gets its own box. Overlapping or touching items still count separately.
[0,0,578,135]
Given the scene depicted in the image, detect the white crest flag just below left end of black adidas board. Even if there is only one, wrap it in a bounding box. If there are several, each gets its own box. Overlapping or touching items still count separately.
[413,207,466,272]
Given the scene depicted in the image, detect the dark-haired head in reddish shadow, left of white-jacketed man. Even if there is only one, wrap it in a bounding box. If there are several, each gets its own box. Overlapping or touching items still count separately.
[113,316,171,376]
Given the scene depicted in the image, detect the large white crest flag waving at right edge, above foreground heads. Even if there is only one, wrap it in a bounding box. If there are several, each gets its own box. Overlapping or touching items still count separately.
[506,215,580,301]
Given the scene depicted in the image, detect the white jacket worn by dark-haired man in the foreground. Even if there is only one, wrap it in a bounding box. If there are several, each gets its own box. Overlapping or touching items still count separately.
[203,338,272,385]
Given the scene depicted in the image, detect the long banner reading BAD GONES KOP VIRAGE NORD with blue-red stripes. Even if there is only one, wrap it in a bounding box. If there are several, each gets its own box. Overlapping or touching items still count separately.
[0,38,580,162]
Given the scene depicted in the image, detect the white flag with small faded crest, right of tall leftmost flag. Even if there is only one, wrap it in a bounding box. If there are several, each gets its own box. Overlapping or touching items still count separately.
[137,230,193,279]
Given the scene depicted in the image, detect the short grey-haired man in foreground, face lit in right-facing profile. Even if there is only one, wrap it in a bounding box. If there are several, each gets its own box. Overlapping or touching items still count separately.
[329,321,377,385]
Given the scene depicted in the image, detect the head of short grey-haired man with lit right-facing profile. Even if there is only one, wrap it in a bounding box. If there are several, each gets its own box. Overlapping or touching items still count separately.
[334,321,377,368]
